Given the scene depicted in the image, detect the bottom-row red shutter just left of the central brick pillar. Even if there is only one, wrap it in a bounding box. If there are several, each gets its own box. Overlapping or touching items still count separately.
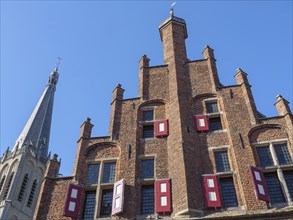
[155,179,172,213]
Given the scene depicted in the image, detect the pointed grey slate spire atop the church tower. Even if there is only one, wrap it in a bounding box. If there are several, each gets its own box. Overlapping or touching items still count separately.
[12,65,59,161]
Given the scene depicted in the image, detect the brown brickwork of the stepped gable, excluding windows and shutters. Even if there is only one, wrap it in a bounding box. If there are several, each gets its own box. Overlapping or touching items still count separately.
[34,13,293,219]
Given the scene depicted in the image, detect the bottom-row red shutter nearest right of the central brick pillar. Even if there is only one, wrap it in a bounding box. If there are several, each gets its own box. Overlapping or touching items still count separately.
[202,175,222,207]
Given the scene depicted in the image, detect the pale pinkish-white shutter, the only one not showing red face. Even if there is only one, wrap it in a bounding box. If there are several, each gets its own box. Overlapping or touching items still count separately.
[112,179,125,215]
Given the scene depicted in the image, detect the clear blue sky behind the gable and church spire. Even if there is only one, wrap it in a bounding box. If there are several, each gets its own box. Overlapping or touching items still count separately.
[0,0,293,175]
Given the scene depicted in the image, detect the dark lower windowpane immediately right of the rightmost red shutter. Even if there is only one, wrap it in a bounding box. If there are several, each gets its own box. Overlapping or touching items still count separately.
[264,173,286,204]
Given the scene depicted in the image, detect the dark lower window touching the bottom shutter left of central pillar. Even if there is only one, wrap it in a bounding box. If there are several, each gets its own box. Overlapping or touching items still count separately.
[141,185,154,214]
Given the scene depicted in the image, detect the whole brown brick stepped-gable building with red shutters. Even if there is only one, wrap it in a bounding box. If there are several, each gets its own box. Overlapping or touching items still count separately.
[34,9,293,219]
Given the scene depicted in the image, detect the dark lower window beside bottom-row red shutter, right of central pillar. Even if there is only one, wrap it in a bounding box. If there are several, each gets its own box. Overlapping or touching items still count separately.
[219,177,238,208]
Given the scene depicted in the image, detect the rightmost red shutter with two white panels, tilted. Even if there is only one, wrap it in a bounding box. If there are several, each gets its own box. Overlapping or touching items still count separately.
[250,166,270,202]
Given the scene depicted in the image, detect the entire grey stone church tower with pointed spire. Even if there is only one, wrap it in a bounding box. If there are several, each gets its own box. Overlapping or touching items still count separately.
[0,67,59,220]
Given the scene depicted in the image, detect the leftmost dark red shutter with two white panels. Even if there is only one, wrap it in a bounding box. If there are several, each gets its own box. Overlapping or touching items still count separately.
[63,184,83,218]
